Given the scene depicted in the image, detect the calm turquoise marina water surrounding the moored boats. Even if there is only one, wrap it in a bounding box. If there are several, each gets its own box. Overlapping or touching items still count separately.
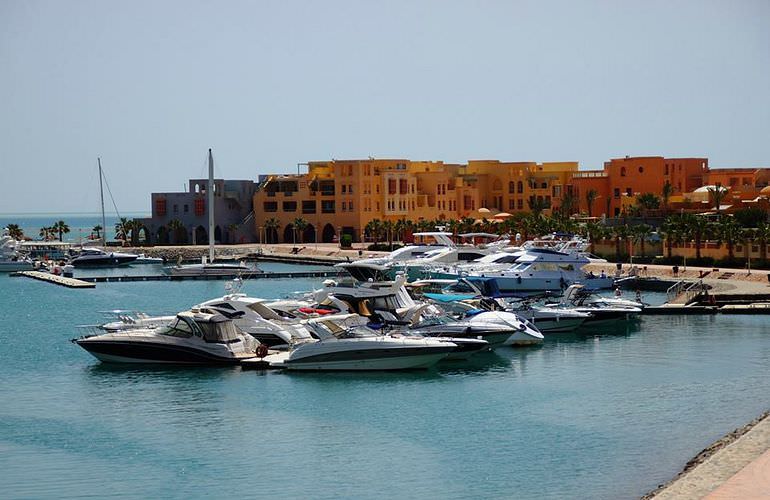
[0,276,770,498]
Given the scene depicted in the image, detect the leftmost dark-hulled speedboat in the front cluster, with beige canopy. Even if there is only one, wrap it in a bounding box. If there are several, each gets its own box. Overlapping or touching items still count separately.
[72,309,259,365]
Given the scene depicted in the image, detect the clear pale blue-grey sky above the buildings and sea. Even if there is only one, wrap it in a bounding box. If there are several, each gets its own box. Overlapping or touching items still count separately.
[0,0,770,213]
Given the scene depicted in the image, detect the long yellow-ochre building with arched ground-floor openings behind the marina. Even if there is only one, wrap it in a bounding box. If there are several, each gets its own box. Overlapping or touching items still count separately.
[254,158,578,243]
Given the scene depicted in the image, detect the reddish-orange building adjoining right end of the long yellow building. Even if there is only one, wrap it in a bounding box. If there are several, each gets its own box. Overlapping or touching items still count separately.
[571,156,709,217]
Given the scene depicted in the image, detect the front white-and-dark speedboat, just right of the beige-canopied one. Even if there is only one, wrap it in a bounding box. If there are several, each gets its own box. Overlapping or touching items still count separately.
[263,314,457,371]
